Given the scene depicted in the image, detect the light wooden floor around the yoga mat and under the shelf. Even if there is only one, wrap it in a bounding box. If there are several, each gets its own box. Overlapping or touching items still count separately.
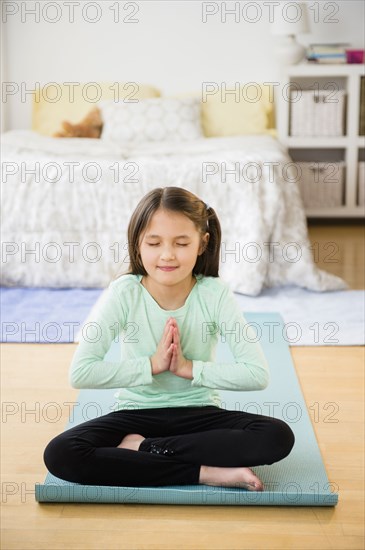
[1,225,365,550]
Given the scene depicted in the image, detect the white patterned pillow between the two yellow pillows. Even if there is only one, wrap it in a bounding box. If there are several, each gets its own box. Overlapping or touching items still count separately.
[99,98,204,144]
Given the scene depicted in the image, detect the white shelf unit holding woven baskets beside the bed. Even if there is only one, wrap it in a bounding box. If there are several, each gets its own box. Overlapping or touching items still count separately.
[276,62,365,218]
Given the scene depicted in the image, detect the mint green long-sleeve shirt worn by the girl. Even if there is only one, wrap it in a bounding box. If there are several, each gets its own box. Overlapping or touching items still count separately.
[69,274,269,410]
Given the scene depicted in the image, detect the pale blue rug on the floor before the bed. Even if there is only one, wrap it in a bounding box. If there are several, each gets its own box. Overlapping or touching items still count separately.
[0,286,365,346]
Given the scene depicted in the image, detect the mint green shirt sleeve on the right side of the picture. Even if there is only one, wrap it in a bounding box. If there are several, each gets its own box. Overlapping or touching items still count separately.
[191,286,270,391]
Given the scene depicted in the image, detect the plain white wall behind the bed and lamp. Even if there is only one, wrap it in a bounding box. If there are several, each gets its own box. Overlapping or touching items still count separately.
[2,0,364,130]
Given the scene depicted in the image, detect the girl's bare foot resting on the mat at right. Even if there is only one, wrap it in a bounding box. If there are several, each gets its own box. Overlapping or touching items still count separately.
[199,466,264,491]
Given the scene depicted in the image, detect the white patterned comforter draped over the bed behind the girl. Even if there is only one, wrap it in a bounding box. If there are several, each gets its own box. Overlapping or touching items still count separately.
[2,130,348,296]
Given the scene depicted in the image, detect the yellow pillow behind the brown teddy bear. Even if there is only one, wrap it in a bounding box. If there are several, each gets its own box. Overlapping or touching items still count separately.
[32,82,161,136]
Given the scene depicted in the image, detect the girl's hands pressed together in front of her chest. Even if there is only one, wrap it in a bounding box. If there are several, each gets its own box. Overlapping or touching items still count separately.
[151,317,193,380]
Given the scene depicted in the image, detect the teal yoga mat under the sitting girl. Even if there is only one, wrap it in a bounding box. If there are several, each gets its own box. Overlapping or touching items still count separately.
[35,312,338,506]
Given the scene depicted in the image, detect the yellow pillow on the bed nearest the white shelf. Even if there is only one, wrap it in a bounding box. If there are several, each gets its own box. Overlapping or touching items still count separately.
[201,82,274,137]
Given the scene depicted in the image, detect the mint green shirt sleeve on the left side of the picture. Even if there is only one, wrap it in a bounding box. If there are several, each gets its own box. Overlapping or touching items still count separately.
[69,283,152,389]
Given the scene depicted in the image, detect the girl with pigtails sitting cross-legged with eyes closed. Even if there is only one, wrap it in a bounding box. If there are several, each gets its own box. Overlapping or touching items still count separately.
[44,187,294,491]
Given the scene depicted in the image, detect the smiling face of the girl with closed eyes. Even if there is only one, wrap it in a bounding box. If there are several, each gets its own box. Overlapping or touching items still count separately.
[139,209,209,284]
